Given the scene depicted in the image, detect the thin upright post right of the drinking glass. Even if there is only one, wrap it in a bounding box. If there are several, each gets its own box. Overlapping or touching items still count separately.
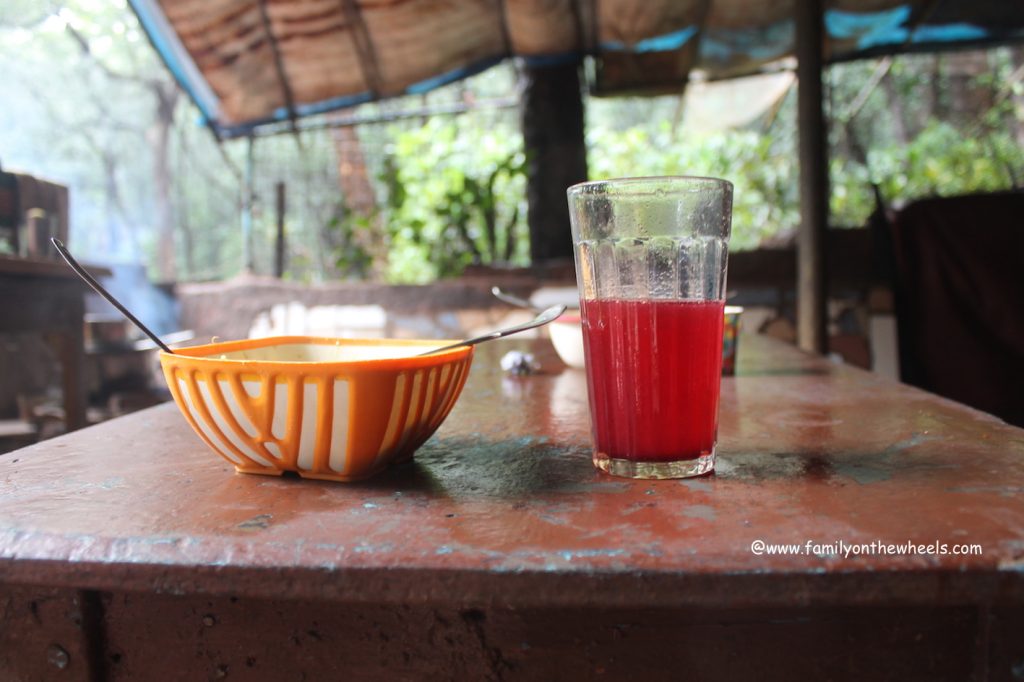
[796,0,828,353]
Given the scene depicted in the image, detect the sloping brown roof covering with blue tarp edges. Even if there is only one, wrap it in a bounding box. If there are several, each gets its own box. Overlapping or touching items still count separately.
[130,0,1024,136]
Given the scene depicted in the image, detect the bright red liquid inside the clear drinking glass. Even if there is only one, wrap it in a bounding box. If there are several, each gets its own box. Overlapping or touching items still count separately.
[583,299,724,462]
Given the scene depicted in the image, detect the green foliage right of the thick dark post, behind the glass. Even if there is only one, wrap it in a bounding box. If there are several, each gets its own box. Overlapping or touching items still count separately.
[587,51,1024,242]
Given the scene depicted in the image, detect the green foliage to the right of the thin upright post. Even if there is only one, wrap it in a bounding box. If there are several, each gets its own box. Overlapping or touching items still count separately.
[830,50,1024,226]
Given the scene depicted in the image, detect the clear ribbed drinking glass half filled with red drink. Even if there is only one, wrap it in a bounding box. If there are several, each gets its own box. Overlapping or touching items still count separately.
[568,177,732,478]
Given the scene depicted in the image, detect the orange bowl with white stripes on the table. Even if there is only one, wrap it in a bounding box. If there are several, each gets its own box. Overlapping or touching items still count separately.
[160,336,473,481]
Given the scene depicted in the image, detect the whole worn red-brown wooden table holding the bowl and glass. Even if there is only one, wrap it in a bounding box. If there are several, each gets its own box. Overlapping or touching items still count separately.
[0,337,1024,681]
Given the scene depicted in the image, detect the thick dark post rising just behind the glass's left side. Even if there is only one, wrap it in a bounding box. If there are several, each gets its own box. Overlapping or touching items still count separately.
[522,61,587,264]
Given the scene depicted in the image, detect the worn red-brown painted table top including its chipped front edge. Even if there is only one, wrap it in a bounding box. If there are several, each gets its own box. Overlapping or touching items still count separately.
[0,336,1024,607]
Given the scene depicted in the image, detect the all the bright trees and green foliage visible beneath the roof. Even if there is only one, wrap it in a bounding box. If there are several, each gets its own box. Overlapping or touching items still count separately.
[0,0,1024,283]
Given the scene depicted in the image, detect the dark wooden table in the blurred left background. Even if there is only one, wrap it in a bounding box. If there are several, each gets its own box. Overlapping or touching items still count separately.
[0,256,110,431]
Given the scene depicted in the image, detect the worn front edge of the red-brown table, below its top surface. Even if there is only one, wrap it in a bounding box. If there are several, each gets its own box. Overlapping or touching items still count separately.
[0,557,1024,608]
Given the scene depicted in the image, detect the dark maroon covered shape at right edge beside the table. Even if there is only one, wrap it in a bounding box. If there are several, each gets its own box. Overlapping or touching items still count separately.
[892,193,1024,426]
